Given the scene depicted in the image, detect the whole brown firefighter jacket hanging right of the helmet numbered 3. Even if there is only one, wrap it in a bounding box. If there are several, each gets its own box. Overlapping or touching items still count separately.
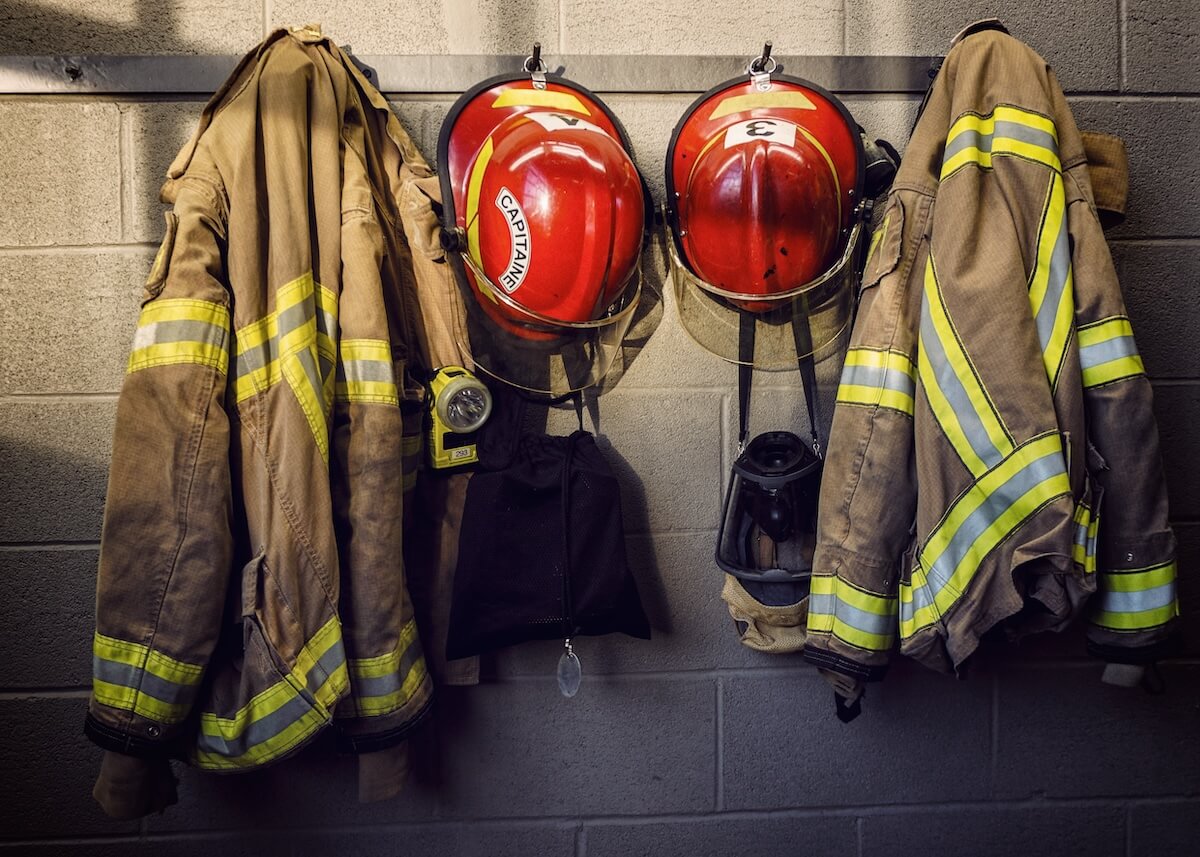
[805,30,1177,687]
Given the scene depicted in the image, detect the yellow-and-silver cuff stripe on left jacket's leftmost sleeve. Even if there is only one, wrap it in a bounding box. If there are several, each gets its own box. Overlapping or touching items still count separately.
[92,633,204,724]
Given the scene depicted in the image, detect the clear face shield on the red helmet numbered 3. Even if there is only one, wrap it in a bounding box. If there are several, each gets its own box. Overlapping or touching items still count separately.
[666,220,863,370]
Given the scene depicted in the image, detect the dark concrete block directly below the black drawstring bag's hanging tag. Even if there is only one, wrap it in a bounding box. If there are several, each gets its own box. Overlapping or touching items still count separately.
[436,666,715,819]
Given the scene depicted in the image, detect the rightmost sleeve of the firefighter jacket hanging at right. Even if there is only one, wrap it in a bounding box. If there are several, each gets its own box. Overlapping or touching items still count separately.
[1068,169,1178,664]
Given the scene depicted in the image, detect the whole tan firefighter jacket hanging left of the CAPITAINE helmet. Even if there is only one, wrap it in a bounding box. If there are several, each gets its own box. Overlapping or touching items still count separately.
[85,29,431,814]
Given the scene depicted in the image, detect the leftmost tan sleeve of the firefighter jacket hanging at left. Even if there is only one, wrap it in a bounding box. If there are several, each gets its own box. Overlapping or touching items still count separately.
[85,182,232,756]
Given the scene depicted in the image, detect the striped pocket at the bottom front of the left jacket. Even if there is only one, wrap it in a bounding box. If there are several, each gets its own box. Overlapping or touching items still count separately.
[192,555,348,771]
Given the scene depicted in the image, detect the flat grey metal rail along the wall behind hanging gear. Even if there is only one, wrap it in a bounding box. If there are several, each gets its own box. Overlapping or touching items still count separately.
[0,54,932,95]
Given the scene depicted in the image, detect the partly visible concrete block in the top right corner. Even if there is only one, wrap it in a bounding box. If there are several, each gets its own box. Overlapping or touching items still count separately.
[1123,0,1200,92]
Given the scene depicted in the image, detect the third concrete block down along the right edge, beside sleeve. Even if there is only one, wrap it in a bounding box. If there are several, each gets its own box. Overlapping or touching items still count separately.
[1112,242,1200,378]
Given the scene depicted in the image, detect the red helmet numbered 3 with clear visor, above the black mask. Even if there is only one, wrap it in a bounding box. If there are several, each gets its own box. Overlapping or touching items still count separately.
[666,73,864,367]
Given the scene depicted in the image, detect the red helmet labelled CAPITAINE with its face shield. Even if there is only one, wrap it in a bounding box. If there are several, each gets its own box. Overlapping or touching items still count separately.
[438,76,647,394]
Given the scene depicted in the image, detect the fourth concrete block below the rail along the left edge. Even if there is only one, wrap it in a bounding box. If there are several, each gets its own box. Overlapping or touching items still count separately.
[0,550,100,688]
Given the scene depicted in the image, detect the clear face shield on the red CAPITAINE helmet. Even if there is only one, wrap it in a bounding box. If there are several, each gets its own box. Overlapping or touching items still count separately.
[455,241,643,396]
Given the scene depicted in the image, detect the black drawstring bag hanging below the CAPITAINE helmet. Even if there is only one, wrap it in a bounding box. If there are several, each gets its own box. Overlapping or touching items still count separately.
[446,431,650,660]
